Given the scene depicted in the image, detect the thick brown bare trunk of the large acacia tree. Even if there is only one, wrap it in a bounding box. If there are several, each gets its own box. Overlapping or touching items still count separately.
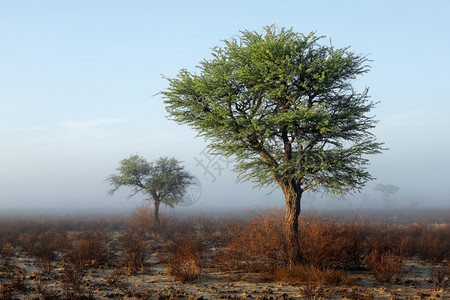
[281,184,303,266]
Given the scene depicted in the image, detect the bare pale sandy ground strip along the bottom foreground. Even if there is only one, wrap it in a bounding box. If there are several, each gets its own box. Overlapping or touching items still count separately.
[0,244,450,299]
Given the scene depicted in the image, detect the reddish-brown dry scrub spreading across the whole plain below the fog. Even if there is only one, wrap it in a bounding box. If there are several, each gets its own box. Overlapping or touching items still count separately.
[0,207,450,299]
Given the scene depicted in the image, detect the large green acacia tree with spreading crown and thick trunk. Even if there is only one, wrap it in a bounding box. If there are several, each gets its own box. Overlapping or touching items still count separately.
[161,26,382,264]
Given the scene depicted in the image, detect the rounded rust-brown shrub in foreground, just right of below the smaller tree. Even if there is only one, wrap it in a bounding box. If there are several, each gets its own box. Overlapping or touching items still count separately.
[164,234,206,281]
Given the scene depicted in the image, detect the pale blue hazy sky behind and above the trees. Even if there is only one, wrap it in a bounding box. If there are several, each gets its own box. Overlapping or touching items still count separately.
[0,0,450,210]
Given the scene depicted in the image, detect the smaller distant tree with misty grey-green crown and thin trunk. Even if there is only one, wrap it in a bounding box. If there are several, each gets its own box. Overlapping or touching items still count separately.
[106,155,194,228]
